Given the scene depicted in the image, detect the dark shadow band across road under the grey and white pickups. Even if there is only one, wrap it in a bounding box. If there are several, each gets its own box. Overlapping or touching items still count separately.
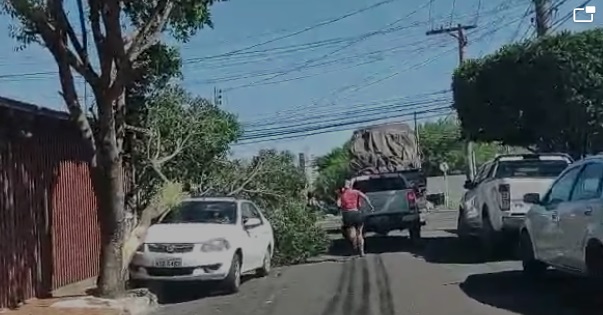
[328,235,514,264]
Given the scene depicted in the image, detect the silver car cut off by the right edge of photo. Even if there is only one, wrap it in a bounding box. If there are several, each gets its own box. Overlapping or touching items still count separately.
[520,156,603,276]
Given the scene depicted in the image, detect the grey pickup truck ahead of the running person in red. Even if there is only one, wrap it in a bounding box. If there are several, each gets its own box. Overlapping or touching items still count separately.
[352,173,425,241]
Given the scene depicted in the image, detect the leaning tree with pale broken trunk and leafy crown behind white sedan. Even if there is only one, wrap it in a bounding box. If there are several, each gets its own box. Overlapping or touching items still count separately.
[122,86,240,269]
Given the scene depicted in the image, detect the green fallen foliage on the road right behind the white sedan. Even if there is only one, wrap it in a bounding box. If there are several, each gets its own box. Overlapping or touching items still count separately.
[216,150,328,264]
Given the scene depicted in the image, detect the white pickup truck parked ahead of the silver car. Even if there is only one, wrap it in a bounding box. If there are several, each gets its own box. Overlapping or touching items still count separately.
[457,153,572,257]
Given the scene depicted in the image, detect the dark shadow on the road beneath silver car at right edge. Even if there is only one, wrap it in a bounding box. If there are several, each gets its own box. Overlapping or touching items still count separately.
[460,270,603,315]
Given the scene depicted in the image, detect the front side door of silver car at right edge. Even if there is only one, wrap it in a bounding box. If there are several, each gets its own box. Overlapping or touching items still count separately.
[528,166,581,266]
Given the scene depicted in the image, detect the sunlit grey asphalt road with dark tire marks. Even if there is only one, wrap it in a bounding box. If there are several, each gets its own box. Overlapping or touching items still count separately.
[150,211,603,315]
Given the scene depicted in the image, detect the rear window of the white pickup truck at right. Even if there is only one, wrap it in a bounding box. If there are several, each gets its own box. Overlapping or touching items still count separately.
[496,160,568,178]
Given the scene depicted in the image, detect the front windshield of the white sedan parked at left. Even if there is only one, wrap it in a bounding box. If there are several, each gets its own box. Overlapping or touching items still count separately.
[161,200,237,224]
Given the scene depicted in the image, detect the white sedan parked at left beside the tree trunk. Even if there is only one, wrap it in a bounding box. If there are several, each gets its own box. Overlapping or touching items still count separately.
[130,198,274,292]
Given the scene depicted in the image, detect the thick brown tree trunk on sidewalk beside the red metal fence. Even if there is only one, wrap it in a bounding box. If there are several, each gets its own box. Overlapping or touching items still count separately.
[94,97,126,298]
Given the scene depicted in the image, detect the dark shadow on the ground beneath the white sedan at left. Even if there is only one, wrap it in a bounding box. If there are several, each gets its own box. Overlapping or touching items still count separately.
[148,275,255,305]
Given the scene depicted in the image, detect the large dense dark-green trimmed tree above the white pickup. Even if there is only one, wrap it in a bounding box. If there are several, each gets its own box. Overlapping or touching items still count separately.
[452,29,603,157]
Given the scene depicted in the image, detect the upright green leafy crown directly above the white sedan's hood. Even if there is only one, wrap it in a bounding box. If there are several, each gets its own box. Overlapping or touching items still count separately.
[132,86,240,207]
